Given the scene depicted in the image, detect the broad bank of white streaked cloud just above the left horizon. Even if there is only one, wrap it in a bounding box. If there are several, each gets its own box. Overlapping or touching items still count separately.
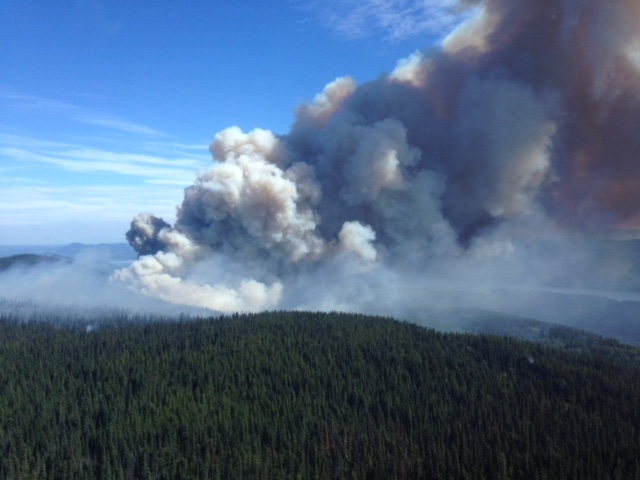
[0,132,211,244]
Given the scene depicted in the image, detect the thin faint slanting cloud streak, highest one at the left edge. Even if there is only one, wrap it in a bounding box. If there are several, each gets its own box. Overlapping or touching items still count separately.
[0,87,165,136]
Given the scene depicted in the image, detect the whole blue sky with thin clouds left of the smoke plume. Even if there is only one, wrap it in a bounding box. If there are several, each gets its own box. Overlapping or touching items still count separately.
[0,0,470,245]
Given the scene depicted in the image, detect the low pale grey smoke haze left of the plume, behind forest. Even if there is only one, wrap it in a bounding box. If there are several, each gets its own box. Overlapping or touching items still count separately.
[0,251,207,323]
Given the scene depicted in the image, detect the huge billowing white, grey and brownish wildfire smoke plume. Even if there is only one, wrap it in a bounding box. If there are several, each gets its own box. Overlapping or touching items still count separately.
[114,0,640,313]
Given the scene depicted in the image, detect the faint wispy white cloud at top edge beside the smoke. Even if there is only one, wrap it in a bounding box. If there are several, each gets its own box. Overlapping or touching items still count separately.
[300,0,469,42]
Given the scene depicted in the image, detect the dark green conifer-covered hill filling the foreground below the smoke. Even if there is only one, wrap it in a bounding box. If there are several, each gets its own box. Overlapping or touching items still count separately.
[0,312,640,479]
